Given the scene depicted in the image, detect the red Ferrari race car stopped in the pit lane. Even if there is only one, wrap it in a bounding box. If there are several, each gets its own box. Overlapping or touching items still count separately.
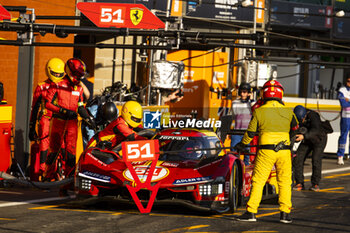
[75,129,278,212]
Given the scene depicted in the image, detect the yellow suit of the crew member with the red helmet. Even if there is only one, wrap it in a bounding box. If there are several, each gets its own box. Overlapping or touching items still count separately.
[242,100,298,213]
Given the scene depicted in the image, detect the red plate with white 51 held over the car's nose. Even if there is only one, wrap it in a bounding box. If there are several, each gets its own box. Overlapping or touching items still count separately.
[122,140,159,162]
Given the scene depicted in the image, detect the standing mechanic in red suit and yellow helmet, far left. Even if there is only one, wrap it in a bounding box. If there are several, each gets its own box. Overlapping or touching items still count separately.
[29,58,64,175]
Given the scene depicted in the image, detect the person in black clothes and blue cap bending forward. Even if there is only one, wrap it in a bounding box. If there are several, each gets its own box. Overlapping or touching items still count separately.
[293,105,327,192]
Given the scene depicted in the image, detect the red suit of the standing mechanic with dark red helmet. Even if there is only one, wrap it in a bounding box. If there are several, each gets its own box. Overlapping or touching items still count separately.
[46,76,83,175]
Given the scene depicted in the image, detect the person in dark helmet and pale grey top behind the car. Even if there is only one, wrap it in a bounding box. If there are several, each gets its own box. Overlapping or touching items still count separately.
[231,82,254,165]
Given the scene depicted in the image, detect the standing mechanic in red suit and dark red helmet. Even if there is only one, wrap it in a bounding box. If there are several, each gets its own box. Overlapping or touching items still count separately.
[45,58,96,176]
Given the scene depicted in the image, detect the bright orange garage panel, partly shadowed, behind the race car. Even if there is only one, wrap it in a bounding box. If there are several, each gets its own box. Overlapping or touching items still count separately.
[167,50,231,119]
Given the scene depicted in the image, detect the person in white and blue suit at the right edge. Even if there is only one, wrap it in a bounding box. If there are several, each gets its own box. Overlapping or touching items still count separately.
[337,76,350,165]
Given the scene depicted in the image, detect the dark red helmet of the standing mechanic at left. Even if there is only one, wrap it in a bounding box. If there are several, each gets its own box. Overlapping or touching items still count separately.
[65,58,86,85]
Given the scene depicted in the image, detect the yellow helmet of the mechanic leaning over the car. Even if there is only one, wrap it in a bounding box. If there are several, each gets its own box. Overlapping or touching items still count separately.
[122,101,142,128]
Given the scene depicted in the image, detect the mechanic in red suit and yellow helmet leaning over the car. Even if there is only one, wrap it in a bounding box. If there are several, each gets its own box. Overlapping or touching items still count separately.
[88,101,147,148]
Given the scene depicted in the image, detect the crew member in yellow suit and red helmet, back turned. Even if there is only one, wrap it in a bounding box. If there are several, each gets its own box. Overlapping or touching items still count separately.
[236,80,298,223]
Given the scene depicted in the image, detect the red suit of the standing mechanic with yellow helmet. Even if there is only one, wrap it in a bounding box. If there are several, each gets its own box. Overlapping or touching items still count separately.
[30,79,53,172]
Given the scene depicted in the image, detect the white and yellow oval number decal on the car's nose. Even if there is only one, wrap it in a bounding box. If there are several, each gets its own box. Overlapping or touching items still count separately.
[123,166,169,182]
